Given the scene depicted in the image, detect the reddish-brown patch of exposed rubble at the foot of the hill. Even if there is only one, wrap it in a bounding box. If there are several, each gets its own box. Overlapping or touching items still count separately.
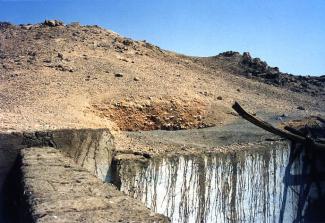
[93,99,213,131]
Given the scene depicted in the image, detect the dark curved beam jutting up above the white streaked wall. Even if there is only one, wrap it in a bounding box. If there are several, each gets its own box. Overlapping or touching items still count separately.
[232,102,325,149]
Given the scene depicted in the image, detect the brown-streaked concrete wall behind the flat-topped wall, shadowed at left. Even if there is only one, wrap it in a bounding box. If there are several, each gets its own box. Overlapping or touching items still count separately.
[0,129,115,199]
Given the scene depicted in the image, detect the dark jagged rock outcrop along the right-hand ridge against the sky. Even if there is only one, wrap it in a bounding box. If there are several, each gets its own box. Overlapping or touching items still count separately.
[213,51,325,96]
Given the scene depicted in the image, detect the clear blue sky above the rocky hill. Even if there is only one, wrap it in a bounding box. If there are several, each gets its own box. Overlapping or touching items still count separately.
[0,0,325,75]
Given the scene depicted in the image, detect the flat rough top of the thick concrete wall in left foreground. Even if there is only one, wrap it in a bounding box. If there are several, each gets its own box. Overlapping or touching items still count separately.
[20,147,169,222]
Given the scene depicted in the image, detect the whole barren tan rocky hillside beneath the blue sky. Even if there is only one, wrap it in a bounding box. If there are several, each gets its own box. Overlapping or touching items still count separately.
[0,20,325,134]
